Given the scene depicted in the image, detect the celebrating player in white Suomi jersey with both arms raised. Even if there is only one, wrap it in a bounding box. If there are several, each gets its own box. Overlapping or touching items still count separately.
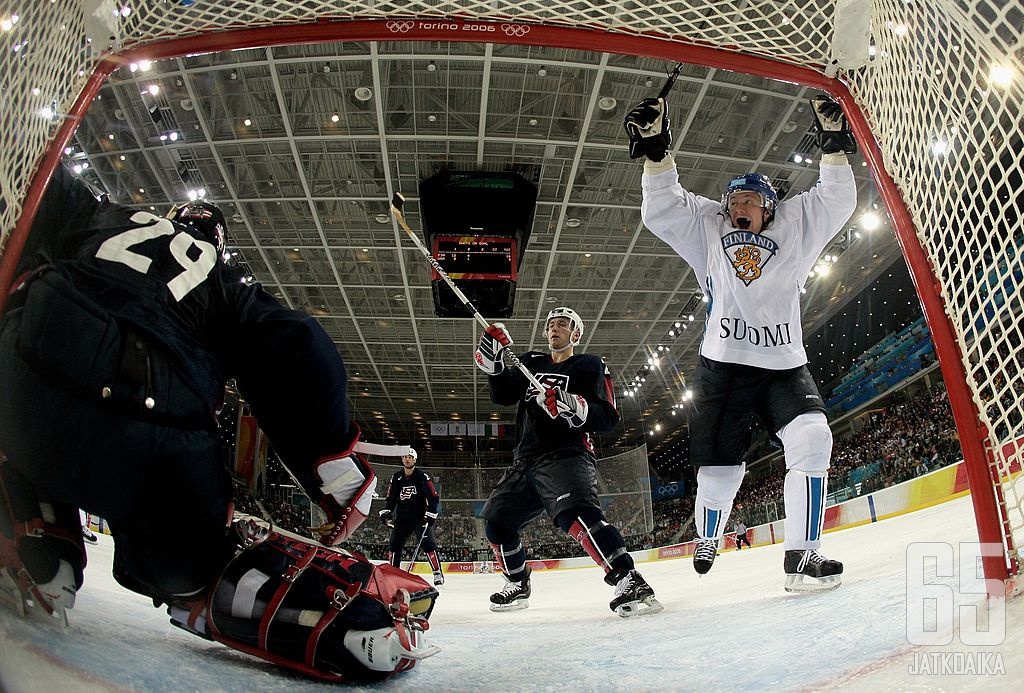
[624,96,857,592]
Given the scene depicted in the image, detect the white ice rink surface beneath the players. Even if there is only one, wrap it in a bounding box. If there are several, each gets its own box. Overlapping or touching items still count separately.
[0,497,1024,693]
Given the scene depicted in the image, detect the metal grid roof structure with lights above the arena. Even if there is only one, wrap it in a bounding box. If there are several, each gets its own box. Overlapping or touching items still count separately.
[70,41,912,450]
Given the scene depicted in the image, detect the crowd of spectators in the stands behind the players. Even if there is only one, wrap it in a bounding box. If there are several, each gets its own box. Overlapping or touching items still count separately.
[228,384,962,561]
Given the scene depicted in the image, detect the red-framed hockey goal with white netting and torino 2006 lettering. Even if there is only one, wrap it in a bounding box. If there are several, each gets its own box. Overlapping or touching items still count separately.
[0,0,1024,593]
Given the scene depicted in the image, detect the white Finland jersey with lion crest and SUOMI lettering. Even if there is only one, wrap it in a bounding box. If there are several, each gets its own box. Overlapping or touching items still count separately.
[641,164,857,371]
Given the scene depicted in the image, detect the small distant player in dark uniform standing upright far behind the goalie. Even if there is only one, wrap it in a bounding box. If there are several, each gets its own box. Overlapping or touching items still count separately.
[380,447,444,586]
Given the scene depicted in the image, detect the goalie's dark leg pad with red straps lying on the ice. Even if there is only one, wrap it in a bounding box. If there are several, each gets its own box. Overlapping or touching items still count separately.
[197,520,438,683]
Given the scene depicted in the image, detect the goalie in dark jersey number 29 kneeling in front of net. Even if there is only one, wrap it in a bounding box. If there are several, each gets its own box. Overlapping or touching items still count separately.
[0,159,437,682]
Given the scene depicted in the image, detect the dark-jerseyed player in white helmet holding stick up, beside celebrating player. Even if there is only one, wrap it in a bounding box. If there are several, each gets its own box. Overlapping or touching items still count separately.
[474,307,662,616]
